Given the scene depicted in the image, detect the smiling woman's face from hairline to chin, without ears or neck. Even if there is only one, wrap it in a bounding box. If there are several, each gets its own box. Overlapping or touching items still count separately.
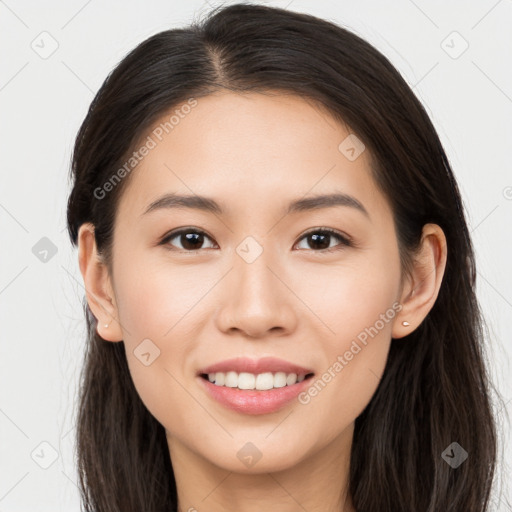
[107,92,401,472]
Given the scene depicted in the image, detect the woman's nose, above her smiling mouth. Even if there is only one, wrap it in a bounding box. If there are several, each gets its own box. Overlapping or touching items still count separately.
[216,251,298,338]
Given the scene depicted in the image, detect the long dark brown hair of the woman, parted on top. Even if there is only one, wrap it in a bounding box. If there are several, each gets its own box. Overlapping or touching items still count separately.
[67,4,497,512]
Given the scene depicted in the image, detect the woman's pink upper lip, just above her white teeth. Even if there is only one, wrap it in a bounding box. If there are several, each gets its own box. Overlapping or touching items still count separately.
[198,357,313,375]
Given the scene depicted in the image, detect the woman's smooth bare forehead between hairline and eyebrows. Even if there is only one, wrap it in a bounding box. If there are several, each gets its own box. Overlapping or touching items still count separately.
[115,91,386,222]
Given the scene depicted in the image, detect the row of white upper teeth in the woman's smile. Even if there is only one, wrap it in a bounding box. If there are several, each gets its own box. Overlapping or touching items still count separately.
[203,372,306,391]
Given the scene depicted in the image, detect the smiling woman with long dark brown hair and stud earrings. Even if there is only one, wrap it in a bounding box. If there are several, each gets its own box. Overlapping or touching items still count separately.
[68,4,496,512]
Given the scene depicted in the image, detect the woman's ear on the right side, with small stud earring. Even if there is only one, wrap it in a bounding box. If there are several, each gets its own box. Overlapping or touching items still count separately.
[392,224,447,338]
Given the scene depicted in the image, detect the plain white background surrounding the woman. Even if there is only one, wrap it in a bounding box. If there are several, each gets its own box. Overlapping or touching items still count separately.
[0,0,512,512]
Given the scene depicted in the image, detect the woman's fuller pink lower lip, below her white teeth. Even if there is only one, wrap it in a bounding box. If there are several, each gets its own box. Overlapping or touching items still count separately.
[198,376,312,414]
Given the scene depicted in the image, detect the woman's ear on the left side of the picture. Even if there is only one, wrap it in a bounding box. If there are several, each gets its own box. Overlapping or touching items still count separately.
[78,223,123,342]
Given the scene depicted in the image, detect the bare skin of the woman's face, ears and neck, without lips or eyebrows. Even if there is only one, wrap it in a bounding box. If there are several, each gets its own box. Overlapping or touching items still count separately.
[79,92,447,512]
